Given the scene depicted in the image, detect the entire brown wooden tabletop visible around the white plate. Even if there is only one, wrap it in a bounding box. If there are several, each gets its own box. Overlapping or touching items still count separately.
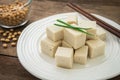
[0,0,120,80]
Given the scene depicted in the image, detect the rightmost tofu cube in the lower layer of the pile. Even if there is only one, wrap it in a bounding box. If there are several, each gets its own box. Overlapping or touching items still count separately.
[86,39,105,58]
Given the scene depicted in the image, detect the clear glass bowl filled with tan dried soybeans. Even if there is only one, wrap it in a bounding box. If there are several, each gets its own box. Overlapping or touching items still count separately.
[0,0,31,28]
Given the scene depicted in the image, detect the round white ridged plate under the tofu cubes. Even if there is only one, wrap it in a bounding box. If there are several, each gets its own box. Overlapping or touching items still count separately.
[17,13,120,80]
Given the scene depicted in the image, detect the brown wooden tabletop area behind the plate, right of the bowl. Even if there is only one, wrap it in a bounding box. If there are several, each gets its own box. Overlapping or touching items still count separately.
[29,0,120,24]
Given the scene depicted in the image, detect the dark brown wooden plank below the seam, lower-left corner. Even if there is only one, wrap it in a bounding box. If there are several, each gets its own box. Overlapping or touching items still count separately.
[0,55,39,80]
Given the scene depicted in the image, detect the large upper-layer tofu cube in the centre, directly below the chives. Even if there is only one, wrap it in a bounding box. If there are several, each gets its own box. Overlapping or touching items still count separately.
[64,28,86,49]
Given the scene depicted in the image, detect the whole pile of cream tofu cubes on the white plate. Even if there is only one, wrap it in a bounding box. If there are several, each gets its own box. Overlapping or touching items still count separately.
[41,16,106,68]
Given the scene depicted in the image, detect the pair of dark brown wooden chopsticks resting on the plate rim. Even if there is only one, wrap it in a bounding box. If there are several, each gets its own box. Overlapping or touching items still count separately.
[67,3,120,38]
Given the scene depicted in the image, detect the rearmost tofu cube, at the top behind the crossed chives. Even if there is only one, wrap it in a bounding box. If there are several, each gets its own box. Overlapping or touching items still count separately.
[64,14,78,24]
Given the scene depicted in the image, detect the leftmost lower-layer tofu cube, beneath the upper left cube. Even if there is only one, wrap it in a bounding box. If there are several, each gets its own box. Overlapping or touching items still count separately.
[41,38,62,57]
